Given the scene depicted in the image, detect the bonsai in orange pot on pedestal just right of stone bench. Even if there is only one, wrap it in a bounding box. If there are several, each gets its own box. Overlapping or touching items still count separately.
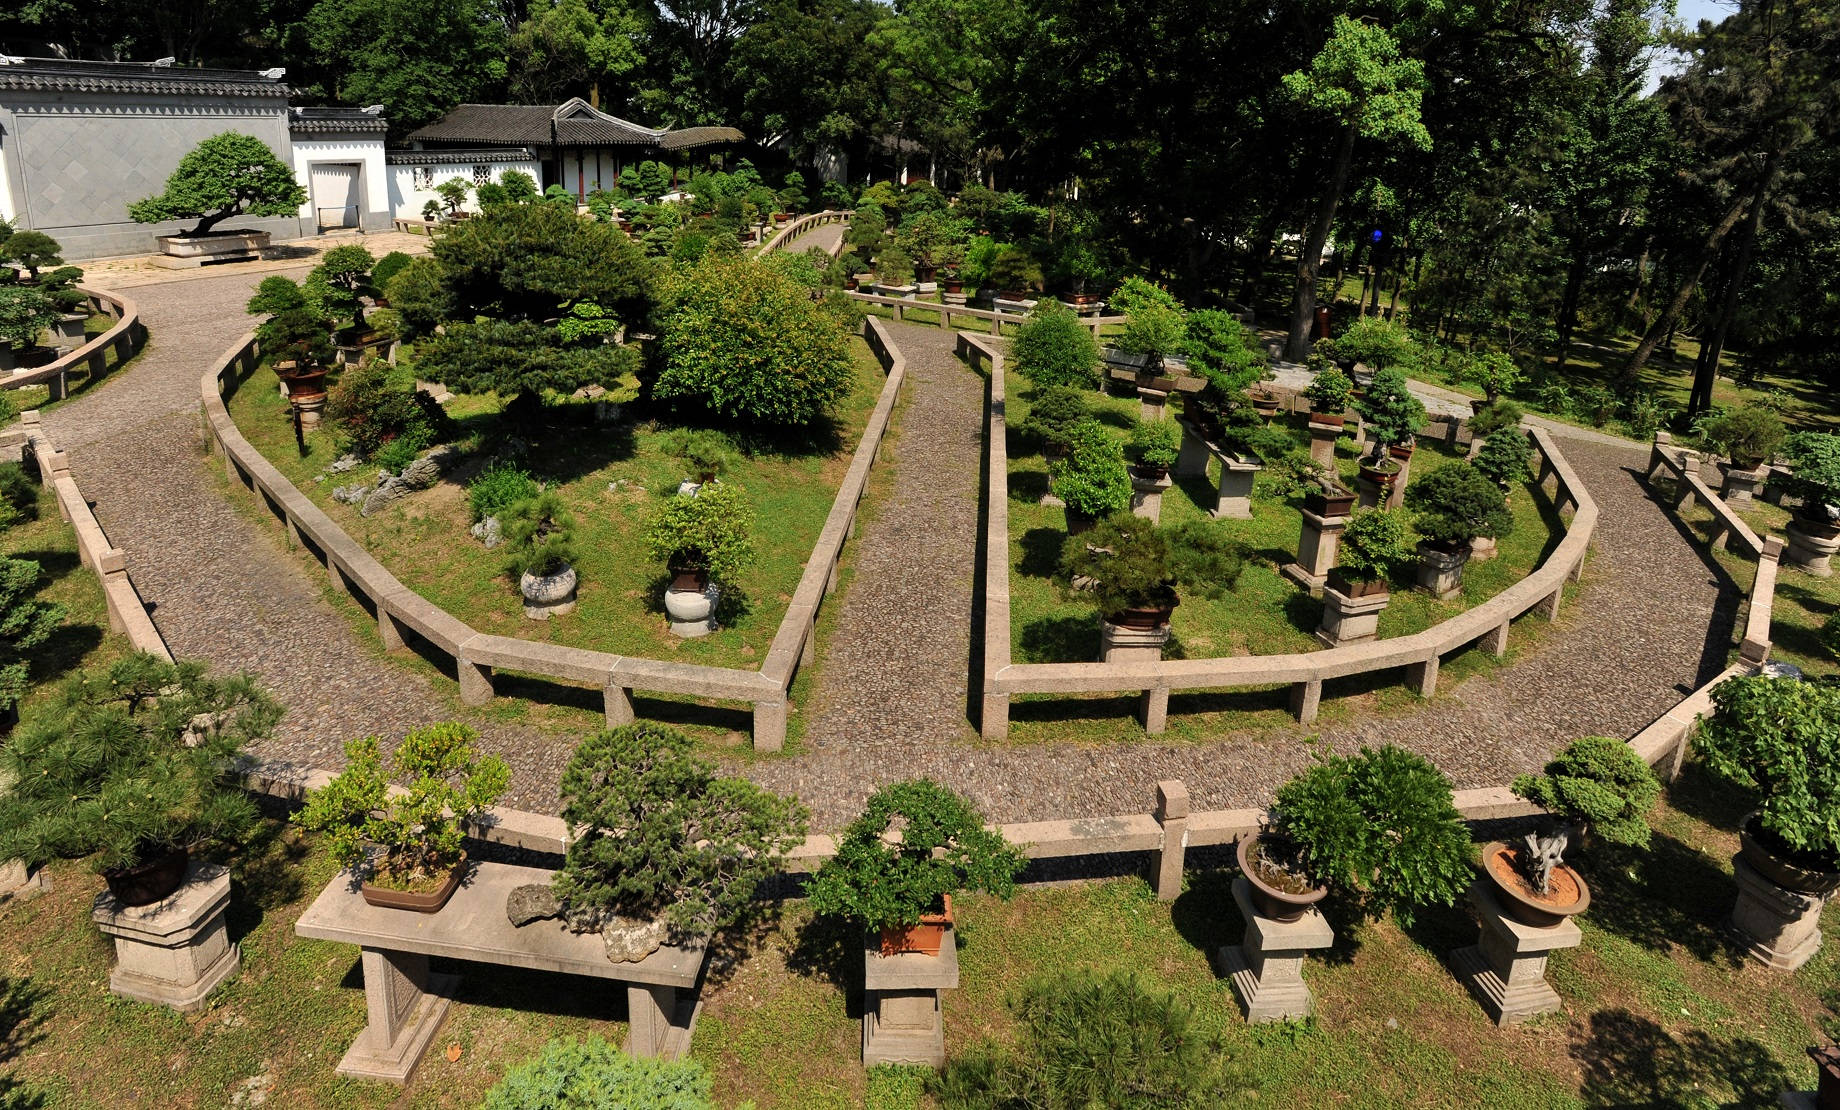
[806,779,1029,955]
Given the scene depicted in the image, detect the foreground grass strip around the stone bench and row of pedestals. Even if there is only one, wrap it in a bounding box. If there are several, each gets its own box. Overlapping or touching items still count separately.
[0,764,1840,1110]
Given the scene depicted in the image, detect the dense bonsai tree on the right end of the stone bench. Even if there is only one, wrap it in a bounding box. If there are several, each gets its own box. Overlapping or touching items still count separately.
[552,722,808,941]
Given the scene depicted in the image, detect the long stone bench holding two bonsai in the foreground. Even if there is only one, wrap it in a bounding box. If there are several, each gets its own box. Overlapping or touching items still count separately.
[294,863,707,1084]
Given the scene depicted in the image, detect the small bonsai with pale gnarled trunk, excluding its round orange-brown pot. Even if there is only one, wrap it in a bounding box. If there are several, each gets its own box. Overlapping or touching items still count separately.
[1514,736,1662,895]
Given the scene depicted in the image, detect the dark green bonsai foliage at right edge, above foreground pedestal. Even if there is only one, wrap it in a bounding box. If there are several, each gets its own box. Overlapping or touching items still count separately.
[1693,676,1840,873]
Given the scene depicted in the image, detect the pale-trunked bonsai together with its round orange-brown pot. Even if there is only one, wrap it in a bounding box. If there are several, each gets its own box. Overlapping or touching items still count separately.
[1483,736,1662,926]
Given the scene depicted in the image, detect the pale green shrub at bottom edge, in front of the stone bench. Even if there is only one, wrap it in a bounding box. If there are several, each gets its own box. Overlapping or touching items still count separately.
[486,1033,716,1110]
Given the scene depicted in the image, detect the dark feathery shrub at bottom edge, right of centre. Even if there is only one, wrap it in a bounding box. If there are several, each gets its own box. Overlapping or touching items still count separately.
[933,972,1233,1110]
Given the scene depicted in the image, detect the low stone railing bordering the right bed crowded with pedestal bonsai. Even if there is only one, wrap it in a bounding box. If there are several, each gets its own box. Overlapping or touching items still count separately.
[960,360,1597,740]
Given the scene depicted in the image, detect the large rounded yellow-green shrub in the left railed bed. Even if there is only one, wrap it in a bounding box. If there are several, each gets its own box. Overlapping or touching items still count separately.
[651,256,856,427]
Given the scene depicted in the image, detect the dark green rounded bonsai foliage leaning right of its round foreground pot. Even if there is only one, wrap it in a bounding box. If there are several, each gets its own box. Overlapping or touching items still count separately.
[1271,744,1474,928]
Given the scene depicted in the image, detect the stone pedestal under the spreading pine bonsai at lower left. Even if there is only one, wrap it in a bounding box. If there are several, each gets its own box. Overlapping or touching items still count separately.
[90,861,241,1011]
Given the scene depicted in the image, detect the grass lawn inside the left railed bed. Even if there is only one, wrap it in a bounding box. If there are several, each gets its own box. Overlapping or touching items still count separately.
[228,341,885,668]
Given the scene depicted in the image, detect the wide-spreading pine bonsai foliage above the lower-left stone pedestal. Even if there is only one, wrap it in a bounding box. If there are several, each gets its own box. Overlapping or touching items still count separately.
[0,653,282,869]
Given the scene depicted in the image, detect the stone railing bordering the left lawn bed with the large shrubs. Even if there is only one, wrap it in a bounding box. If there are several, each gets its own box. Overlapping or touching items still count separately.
[201,320,907,751]
